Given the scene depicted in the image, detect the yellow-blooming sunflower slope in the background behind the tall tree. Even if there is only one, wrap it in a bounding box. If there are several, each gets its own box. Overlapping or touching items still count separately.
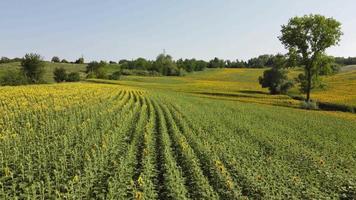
[94,68,356,110]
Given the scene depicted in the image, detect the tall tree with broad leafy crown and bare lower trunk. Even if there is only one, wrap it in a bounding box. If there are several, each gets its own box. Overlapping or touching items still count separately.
[279,15,342,101]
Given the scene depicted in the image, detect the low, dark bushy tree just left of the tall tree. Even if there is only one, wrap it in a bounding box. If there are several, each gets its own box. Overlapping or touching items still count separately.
[259,55,293,94]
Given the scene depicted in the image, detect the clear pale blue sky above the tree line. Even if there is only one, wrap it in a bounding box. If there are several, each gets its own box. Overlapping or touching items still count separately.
[0,0,356,61]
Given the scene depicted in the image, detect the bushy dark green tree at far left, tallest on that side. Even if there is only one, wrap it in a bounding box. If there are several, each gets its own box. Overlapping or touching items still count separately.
[21,53,45,83]
